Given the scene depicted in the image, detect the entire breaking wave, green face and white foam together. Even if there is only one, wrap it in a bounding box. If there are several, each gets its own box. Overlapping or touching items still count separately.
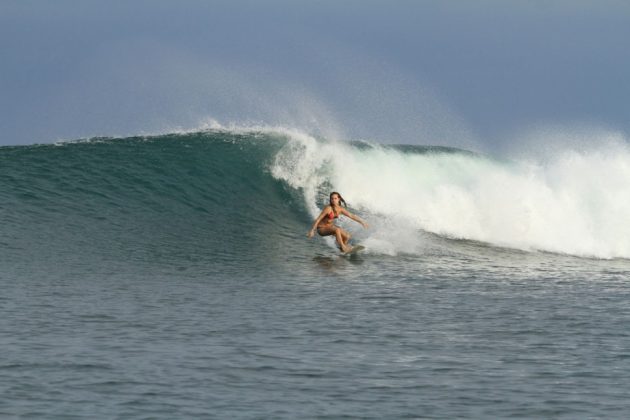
[0,129,630,268]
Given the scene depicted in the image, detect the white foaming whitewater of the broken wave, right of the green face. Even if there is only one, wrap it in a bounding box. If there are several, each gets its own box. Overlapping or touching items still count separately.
[271,132,630,258]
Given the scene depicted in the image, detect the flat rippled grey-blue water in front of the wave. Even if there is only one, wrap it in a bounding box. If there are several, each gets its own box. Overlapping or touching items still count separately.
[0,245,630,419]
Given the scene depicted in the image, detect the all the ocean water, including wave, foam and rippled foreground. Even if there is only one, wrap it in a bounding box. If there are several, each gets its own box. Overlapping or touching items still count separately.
[0,129,630,419]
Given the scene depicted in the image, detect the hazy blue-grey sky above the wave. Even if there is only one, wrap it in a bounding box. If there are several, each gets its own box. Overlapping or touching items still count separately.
[0,0,630,149]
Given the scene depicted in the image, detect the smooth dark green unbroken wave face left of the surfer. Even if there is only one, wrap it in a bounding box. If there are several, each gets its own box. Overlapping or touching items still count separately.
[0,132,304,272]
